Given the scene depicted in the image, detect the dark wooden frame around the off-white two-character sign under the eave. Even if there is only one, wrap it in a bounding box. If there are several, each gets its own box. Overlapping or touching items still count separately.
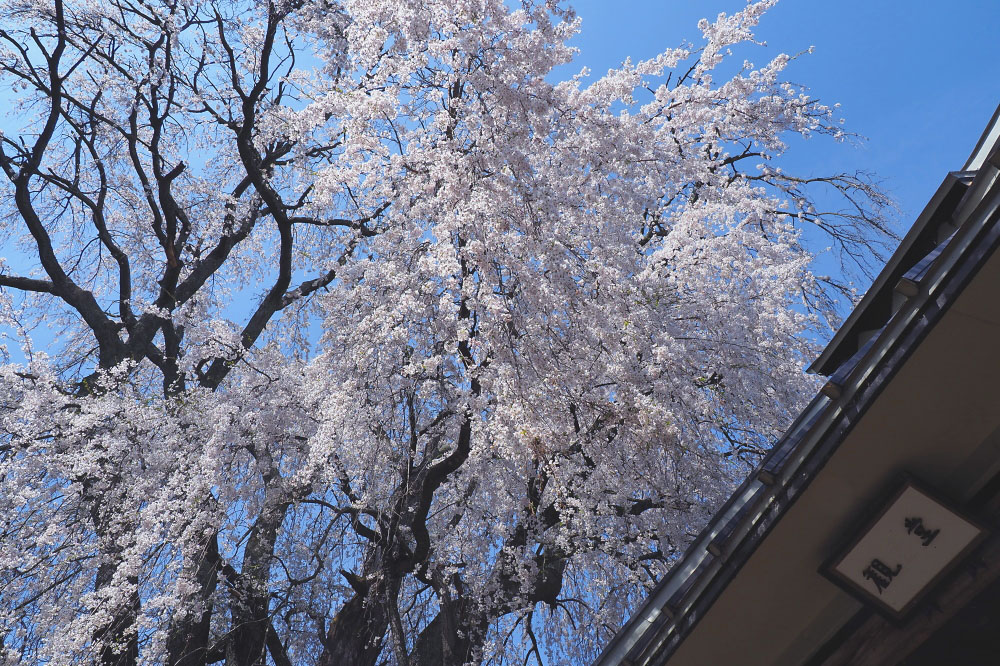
[819,472,990,626]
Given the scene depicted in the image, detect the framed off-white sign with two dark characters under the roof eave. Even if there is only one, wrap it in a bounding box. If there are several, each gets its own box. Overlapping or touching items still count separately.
[823,479,986,619]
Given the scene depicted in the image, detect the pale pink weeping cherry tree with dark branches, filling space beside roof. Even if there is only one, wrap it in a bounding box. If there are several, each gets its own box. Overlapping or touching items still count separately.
[0,0,886,666]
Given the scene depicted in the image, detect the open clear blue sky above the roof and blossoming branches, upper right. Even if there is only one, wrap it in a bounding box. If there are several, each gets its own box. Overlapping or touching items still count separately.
[571,0,1000,230]
